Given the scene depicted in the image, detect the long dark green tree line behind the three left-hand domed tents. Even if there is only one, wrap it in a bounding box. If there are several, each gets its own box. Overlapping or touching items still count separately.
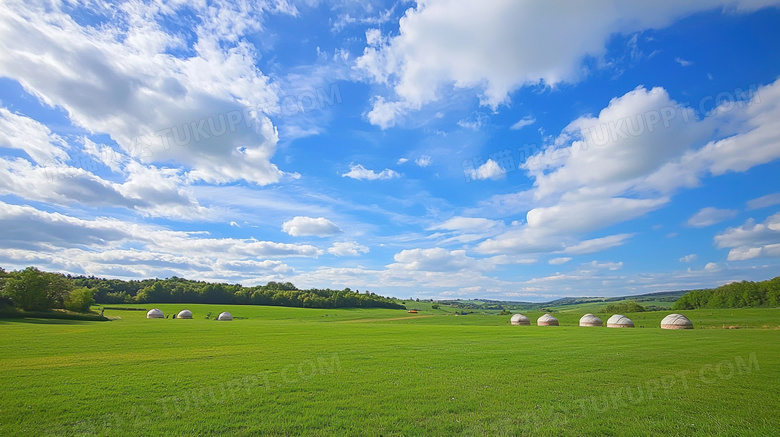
[0,267,405,310]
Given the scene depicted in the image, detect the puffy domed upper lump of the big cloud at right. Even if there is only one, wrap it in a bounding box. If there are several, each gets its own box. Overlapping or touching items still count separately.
[524,87,711,197]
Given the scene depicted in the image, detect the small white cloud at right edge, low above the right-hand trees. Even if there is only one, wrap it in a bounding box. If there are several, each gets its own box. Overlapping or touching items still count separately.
[715,212,780,261]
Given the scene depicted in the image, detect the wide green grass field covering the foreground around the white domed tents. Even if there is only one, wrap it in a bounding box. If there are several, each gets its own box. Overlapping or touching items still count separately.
[0,304,780,436]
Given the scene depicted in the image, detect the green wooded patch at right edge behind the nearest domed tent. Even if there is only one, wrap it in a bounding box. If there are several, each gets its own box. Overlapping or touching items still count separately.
[673,276,780,310]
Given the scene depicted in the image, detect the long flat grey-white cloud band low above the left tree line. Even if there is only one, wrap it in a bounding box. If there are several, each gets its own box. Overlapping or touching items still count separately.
[0,202,330,284]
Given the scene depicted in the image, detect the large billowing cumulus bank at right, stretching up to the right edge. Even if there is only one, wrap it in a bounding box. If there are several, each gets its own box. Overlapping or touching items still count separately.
[476,76,780,256]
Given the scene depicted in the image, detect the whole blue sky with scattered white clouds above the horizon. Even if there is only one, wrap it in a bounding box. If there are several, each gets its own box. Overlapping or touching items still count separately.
[0,0,780,301]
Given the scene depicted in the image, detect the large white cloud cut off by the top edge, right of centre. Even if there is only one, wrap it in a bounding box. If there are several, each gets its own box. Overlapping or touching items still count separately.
[356,0,776,128]
